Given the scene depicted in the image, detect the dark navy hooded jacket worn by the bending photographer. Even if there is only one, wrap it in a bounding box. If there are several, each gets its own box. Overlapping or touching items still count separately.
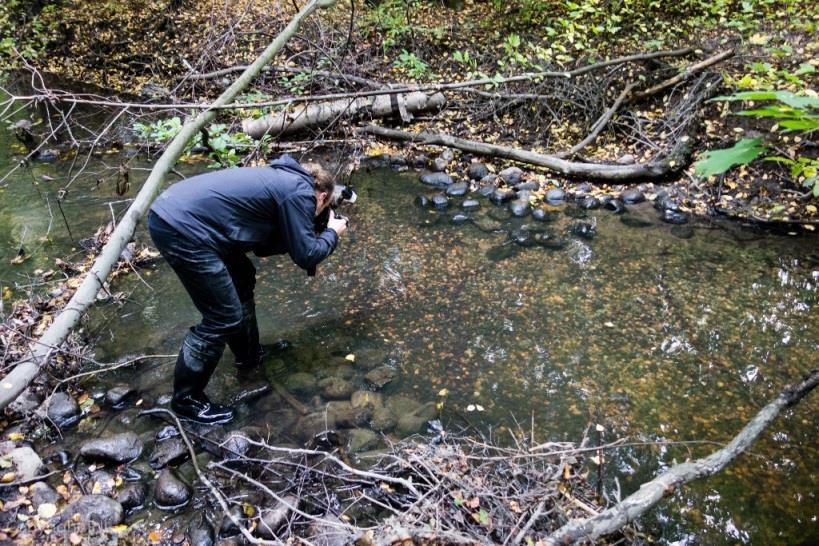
[151,155,338,270]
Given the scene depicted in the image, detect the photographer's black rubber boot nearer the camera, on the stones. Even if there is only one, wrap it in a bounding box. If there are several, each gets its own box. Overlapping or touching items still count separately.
[171,328,233,425]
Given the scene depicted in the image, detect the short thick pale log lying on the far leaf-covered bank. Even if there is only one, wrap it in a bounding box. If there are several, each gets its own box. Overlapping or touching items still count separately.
[242,91,446,139]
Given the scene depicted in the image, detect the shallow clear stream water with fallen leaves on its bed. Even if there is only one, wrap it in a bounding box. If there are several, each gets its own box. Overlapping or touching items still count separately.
[0,119,819,545]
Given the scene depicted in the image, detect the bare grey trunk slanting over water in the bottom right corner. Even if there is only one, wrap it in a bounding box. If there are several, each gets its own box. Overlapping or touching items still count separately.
[545,370,819,546]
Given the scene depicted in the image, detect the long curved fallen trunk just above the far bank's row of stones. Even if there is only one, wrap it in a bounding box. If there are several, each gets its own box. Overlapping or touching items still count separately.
[356,125,691,182]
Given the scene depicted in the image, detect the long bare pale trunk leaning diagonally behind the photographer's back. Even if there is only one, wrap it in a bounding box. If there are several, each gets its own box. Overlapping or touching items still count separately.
[0,0,336,409]
